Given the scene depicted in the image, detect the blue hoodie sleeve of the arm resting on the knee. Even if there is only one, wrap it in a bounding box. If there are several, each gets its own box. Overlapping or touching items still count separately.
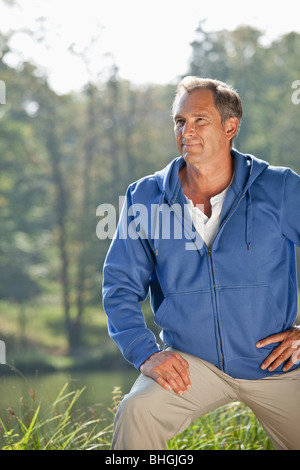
[103,187,160,369]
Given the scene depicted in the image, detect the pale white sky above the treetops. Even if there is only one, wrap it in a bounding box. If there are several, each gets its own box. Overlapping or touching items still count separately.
[0,0,300,93]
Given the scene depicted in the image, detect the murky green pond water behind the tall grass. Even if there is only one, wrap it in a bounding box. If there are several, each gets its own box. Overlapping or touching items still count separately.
[0,369,138,421]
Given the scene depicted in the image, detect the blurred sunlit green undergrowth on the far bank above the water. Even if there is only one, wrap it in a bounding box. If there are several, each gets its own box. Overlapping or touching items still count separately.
[0,293,113,370]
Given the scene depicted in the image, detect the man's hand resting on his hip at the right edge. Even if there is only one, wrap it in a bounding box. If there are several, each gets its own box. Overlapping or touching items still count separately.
[256,326,300,372]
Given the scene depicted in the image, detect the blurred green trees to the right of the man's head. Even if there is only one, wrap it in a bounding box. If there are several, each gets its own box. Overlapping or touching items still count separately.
[189,23,300,172]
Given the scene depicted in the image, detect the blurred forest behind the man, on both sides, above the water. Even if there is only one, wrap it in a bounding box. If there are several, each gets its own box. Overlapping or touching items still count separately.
[0,4,300,373]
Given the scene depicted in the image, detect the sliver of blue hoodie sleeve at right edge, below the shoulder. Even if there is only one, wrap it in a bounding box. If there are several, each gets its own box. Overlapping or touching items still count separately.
[281,170,300,246]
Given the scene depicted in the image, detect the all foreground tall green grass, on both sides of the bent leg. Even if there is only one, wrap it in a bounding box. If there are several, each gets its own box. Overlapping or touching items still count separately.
[0,383,273,450]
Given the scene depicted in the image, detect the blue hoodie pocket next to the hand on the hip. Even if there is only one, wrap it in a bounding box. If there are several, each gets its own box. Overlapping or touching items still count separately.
[219,285,284,361]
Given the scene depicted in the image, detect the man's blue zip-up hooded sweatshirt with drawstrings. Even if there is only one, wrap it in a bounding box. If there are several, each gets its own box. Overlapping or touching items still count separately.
[103,149,300,379]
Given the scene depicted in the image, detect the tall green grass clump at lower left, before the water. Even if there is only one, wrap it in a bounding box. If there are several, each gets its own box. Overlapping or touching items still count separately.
[0,383,118,450]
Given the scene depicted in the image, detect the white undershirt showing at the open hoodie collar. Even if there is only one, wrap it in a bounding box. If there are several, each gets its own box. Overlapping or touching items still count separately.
[185,186,229,247]
